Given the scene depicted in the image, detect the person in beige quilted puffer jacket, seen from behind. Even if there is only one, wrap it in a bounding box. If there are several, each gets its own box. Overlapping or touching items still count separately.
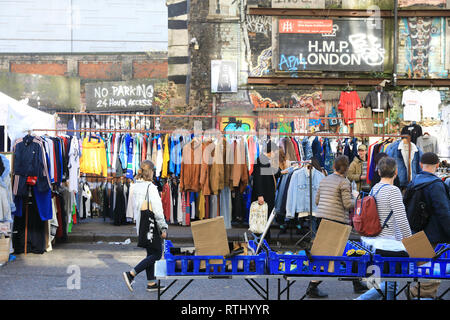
[307,156,368,298]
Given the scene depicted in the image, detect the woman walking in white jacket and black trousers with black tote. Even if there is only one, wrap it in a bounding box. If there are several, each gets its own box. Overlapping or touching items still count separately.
[123,160,167,291]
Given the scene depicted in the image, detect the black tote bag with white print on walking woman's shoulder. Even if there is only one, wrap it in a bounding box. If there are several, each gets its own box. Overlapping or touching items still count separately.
[138,185,162,249]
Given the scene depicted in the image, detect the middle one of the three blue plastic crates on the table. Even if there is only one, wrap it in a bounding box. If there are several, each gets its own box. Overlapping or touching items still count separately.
[269,241,370,277]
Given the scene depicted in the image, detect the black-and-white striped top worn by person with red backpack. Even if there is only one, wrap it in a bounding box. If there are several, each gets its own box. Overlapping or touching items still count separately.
[366,183,411,241]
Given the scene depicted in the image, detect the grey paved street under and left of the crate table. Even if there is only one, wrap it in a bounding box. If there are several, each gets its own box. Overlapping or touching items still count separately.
[0,243,448,300]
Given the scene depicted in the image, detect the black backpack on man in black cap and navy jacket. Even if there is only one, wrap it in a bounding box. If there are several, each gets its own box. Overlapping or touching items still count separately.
[403,179,448,232]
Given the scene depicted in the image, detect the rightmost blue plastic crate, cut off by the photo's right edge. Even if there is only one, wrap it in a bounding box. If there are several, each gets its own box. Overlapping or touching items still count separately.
[373,244,450,279]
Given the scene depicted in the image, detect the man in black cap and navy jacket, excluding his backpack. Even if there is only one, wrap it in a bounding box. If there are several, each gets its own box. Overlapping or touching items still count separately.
[408,152,450,298]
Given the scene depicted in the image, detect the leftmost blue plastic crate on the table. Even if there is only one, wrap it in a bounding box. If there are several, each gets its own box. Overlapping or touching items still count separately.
[164,240,267,276]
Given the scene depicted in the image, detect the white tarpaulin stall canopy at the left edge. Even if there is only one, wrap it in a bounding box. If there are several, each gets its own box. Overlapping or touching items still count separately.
[0,92,56,143]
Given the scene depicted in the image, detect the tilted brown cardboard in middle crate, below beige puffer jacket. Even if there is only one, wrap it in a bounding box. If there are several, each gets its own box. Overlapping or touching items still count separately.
[311,219,352,272]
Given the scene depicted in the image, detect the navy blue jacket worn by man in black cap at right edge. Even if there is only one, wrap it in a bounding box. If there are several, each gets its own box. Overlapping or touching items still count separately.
[411,171,450,244]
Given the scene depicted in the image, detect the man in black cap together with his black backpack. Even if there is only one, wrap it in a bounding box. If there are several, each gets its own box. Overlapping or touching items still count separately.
[404,152,450,298]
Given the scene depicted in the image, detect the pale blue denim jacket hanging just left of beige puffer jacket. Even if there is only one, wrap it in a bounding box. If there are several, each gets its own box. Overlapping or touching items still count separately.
[286,168,325,218]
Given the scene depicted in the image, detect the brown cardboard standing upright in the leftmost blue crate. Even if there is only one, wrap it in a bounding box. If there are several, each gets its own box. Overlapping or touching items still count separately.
[191,217,230,268]
